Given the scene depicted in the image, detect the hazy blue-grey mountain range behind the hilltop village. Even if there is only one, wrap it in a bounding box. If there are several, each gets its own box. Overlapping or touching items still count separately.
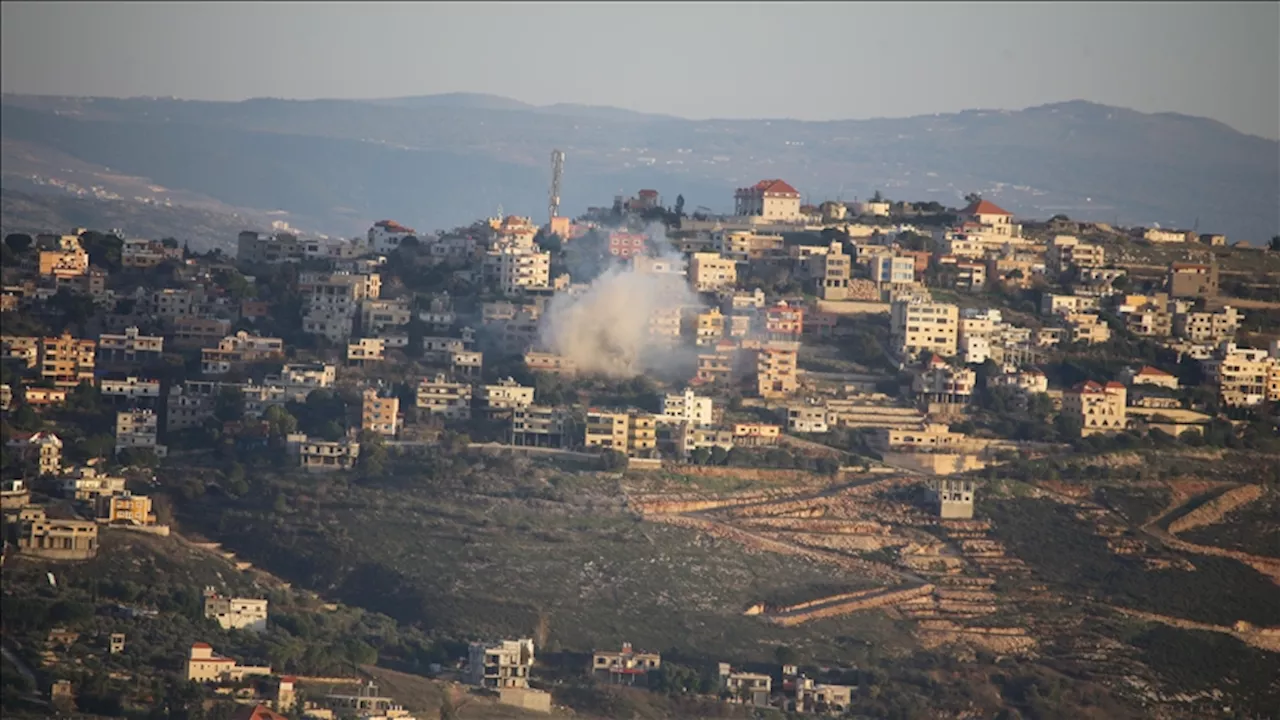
[0,94,1280,242]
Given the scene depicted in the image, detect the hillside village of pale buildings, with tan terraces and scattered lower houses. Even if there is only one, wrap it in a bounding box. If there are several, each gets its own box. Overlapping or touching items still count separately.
[0,179,1280,720]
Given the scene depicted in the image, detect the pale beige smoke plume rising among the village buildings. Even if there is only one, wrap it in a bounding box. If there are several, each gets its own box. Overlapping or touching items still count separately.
[539,223,701,378]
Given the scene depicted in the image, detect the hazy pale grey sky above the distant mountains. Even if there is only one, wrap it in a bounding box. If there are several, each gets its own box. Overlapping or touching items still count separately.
[0,0,1280,138]
